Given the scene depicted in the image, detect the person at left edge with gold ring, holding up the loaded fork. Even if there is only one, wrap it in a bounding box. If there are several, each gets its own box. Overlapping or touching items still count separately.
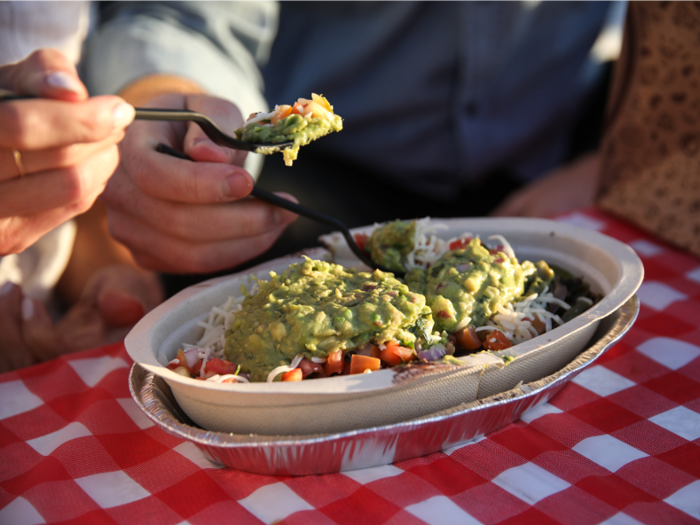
[0,2,163,372]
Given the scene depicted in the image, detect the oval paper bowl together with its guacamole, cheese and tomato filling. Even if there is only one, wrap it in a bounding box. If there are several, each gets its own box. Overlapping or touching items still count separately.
[125,218,643,436]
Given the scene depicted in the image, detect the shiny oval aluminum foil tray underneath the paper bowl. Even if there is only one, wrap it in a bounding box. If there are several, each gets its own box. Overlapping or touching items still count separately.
[129,296,639,476]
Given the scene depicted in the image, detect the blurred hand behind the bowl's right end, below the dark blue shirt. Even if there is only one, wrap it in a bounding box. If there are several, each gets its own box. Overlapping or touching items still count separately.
[491,153,600,217]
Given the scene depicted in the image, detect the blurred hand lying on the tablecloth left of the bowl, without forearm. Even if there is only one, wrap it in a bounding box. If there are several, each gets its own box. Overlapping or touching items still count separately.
[0,265,163,372]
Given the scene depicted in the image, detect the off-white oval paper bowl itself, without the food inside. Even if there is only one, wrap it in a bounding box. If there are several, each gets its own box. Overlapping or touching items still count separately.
[125,219,644,436]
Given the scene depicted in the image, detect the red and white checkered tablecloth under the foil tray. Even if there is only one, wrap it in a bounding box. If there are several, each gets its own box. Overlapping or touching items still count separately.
[0,211,700,525]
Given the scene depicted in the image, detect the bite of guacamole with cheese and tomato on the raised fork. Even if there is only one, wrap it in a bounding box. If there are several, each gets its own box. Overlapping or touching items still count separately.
[234,93,343,166]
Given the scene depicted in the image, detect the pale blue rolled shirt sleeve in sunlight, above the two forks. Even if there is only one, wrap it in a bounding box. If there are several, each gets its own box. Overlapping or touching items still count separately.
[82,0,279,116]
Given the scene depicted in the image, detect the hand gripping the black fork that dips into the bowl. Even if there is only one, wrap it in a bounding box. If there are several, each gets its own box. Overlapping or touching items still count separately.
[103,93,296,273]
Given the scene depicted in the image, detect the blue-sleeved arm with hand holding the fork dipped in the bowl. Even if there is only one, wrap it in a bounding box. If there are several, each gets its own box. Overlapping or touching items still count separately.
[80,1,296,273]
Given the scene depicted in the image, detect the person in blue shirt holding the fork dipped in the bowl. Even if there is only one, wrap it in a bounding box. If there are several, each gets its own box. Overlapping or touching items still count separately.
[85,0,621,290]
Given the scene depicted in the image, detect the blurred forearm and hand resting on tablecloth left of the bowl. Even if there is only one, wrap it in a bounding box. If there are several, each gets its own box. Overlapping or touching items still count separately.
[0,200,164,372]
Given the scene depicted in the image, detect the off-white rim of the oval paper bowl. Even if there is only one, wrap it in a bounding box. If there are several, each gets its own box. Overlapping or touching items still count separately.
[124,218,644,395]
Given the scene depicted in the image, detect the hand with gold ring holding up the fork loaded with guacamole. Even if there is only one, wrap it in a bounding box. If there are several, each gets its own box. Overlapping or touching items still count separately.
[0,49,134,256]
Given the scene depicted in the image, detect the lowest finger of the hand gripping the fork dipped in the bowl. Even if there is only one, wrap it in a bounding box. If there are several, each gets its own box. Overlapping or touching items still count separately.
[110,211,284,273]
